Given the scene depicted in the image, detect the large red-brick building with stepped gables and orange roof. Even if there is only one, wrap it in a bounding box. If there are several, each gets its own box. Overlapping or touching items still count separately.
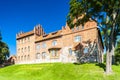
[16,21,103,64]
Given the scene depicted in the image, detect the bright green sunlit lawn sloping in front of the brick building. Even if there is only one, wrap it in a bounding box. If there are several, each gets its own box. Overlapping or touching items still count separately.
[0,63,120,80]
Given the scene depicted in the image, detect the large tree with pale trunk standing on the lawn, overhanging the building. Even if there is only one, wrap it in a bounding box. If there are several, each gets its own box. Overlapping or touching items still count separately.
[67,0,120,74]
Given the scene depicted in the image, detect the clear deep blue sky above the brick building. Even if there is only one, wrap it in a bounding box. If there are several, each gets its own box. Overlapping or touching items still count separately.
[0,0,69,55]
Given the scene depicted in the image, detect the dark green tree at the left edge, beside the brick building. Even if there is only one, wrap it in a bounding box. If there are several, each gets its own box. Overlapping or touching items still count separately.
[0,33,10,64]
